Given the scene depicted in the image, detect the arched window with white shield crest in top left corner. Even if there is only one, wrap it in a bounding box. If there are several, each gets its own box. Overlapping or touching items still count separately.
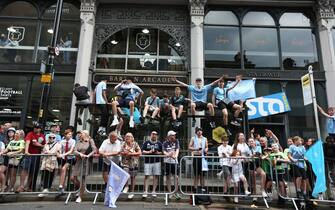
[0,1,37,63]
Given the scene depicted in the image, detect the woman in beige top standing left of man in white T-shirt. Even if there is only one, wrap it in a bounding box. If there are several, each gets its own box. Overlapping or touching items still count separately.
[71,130,97,203]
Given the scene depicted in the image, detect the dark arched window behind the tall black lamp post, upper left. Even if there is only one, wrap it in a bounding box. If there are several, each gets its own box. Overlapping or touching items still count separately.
[38,3,80,64]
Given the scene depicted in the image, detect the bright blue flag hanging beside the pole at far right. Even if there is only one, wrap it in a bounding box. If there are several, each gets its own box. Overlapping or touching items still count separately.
[305,140,327,198]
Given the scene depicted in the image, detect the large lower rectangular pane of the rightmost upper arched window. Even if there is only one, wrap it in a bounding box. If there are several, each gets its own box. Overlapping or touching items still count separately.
[280,29,318,69]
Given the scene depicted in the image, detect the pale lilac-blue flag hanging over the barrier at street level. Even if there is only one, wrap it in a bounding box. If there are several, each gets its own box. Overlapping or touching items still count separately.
[104,161,129,208]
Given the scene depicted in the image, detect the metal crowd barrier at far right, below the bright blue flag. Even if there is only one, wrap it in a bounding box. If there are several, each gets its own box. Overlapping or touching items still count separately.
[273,159,335,210]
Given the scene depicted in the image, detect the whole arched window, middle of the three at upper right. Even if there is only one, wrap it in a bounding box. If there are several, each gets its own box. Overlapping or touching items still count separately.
[242,12,280,69]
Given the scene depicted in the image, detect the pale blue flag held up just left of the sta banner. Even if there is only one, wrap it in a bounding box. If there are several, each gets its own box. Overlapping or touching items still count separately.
[227,79,256,101]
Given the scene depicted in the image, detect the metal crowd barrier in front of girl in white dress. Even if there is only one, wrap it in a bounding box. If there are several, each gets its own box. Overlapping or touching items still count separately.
[179,156,271,208]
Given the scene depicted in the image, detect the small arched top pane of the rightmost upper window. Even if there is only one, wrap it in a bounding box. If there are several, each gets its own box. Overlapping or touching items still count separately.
[279,13,311,27]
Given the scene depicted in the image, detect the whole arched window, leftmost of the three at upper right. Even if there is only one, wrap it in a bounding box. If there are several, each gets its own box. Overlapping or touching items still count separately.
[204,11,241,68]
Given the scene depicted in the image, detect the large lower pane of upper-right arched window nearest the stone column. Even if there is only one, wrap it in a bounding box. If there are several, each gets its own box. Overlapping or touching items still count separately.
[204,26,241,68]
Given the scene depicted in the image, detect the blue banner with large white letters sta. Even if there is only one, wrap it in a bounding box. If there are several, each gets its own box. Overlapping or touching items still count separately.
[246,92,291,120]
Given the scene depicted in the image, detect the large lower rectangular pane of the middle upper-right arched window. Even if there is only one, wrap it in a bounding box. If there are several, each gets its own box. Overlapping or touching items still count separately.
[242,28,279,68]
